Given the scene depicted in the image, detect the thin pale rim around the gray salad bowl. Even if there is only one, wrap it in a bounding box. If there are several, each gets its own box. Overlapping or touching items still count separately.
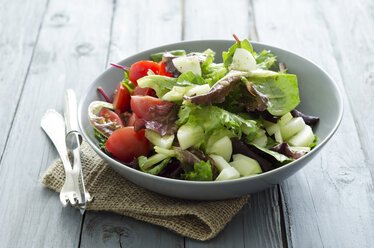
[78,39,344,186]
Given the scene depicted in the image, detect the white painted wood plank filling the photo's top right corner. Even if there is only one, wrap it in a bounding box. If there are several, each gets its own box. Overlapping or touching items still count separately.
[318,0,374,180]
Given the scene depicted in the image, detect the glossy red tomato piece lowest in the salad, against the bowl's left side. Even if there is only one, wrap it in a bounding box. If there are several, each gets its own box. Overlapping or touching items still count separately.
[105,127,149,162]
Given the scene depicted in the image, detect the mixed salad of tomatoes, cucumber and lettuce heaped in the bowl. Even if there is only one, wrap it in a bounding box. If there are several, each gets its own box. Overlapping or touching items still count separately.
[88,35,319,181]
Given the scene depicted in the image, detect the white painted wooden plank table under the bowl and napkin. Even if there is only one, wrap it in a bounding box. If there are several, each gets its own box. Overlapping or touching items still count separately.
[0,0,374,247]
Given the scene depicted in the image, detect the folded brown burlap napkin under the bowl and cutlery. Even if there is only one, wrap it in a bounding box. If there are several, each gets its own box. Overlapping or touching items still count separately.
[42,142,248,240]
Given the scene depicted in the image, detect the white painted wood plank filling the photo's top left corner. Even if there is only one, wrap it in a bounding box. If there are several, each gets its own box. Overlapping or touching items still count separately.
[0,0,47,158]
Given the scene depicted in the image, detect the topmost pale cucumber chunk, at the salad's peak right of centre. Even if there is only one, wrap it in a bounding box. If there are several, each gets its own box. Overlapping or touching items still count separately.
[230,48,257,71]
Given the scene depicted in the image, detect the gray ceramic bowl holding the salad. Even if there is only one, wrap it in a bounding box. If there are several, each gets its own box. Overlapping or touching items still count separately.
[78,40,343,200]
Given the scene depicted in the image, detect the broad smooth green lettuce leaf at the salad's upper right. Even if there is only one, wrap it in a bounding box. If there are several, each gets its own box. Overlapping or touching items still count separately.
[244,74,300,116]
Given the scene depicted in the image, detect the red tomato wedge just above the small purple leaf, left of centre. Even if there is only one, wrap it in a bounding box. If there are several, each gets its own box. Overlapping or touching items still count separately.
[130,96,174,118]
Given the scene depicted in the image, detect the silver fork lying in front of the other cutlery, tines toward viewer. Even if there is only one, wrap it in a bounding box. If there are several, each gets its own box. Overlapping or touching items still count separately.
[41,109,81,207]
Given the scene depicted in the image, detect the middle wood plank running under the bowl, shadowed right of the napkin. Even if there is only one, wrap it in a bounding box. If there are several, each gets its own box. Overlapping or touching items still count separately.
[184,0,282,247]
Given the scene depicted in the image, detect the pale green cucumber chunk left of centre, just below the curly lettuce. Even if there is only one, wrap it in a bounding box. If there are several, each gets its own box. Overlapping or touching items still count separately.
[177,124,204,150]
